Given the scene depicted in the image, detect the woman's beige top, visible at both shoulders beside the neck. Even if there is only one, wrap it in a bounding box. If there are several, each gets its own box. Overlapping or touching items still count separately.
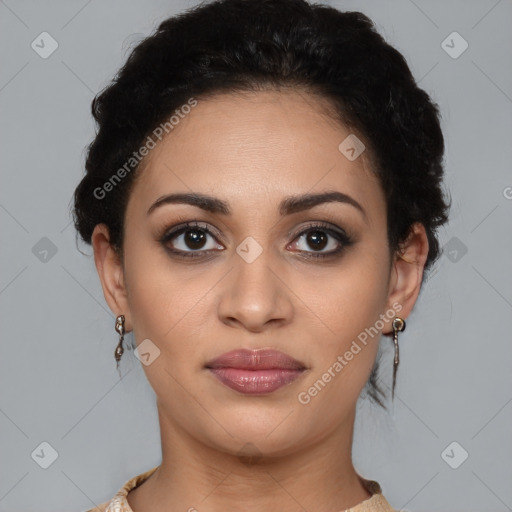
[85,466,399,512]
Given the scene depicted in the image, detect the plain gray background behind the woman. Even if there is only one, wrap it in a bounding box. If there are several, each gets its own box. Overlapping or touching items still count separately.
[0,0,512,512]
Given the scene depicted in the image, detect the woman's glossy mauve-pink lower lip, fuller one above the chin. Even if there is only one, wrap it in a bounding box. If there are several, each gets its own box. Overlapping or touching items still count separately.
[209,368,303,394]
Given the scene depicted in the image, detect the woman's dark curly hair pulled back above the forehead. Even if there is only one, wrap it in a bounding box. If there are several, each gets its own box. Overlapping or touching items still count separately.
[73,0,451,408]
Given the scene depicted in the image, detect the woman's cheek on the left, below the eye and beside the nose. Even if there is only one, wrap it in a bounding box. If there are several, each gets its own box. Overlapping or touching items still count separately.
[125,252,208,404]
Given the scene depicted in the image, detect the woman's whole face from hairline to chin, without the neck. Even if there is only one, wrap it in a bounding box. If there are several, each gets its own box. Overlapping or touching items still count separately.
[96,91,421,454]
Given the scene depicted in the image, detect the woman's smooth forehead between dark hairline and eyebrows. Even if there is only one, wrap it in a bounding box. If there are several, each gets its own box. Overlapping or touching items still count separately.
[129,91,383,218]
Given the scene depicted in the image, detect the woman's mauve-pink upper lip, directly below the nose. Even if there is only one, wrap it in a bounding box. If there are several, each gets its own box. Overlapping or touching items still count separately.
[205,349,305,370]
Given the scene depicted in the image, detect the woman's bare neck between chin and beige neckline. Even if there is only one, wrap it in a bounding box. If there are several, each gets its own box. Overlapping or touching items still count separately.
[128,409,370,512]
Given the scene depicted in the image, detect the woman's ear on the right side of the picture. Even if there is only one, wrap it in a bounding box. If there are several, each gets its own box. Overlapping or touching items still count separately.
[383,222,429,334]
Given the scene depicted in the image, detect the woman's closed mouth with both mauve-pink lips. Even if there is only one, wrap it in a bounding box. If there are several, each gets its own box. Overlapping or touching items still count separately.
[205,349,306,395]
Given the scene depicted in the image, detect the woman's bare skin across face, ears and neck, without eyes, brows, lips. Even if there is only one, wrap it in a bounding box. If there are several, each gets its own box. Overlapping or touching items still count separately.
[92,90,428,512]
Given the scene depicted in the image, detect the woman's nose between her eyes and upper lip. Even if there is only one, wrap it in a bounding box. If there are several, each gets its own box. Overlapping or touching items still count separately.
[218,250,294,332]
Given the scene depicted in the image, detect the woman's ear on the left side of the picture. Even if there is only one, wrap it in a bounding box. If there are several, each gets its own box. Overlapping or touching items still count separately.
[91,224,132,332]
